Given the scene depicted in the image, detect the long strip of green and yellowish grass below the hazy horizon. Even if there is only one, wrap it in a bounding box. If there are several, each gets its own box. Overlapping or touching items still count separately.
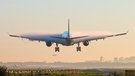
[7,71,104,76]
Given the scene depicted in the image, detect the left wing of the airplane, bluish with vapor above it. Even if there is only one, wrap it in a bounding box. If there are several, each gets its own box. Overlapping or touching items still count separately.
[8,33,64,44]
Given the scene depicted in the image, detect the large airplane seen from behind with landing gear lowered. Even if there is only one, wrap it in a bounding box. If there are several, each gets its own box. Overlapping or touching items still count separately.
[8,19,128,52]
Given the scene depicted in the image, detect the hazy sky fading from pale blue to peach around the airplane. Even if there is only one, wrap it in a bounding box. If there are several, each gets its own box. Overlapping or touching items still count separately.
[0,0,135,62]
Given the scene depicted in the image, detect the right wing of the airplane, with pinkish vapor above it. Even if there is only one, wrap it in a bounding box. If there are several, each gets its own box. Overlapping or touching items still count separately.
[73,31,128,43]
